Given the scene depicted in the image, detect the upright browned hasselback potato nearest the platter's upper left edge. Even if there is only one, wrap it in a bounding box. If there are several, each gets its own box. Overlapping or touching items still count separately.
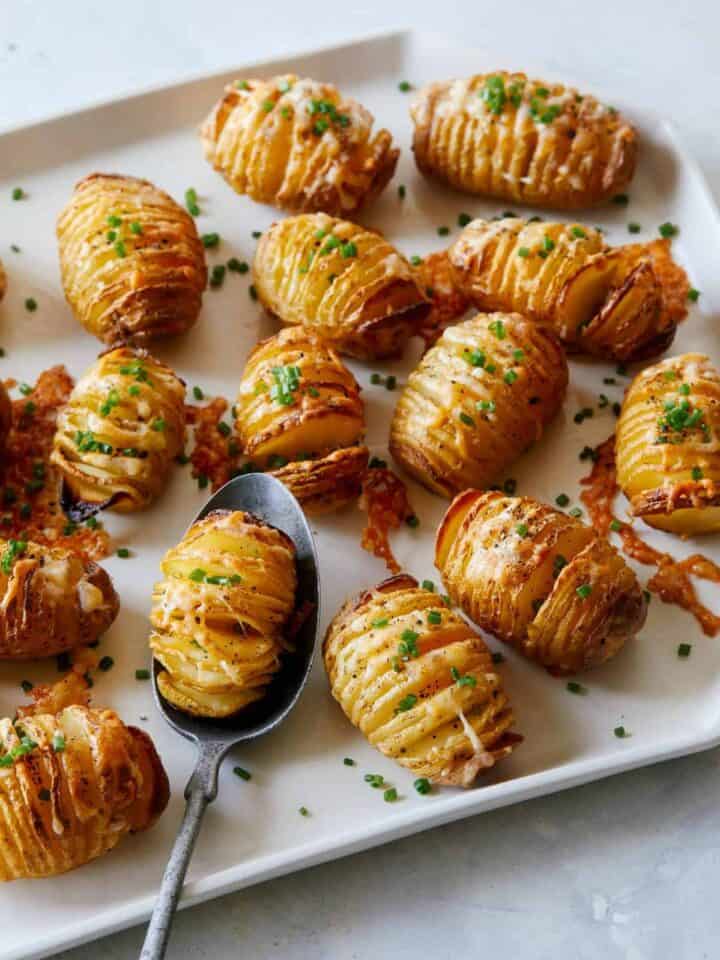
[57,173,207,346]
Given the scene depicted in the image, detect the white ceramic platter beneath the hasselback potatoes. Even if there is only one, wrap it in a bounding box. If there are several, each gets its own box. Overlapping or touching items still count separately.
[0,34,720,958]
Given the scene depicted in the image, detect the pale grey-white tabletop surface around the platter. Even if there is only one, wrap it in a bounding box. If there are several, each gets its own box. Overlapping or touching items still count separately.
[0,0,720,960]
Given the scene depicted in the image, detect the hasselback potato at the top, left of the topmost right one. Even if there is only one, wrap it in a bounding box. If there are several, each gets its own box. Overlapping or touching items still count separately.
[201,74,400,215]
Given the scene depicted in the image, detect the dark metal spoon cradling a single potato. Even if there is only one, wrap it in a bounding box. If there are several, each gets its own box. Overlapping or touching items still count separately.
[140,473,320,960]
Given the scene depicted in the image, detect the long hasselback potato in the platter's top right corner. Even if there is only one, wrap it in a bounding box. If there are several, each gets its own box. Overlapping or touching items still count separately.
[410,71,638,210]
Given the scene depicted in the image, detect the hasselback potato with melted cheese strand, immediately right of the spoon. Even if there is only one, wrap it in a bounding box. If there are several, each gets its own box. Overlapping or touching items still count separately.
[323,574,521,787]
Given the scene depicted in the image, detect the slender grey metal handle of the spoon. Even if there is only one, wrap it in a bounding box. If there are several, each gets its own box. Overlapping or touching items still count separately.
[140,742,228,960]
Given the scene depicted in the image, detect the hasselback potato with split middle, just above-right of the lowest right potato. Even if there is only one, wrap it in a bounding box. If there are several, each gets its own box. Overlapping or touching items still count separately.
[435,490,647,674]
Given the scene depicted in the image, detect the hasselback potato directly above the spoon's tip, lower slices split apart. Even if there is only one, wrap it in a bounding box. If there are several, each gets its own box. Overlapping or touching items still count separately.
[235,327,368,512]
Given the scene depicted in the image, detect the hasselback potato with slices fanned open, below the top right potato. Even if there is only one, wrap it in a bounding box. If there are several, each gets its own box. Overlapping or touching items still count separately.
[449,217,677,361]
